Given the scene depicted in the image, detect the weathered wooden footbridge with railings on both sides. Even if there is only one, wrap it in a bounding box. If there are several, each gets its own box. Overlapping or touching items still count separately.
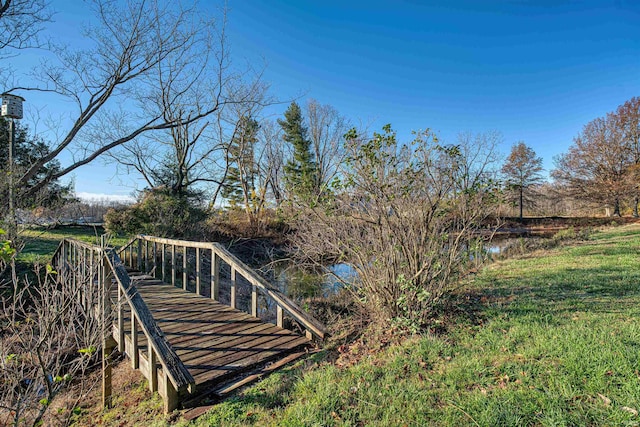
[52,235,326,412]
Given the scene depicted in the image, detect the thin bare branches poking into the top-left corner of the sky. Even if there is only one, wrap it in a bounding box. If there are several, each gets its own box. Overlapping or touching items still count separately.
[0,0,52,53]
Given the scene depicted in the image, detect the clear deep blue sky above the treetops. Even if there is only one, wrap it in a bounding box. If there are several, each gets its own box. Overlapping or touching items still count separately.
[6,0,640,201]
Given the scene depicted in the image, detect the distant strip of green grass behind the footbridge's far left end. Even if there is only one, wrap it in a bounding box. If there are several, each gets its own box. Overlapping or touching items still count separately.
[18,226,128,264]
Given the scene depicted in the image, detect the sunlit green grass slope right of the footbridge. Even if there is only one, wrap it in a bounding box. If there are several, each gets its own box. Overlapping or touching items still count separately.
[184,226,640,426]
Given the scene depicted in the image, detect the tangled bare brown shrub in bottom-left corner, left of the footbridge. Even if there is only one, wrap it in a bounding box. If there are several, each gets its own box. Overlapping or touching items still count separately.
[0,266,102,426]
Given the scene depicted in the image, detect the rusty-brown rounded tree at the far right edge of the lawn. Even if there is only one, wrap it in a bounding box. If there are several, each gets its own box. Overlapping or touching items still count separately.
[551,114,635,216]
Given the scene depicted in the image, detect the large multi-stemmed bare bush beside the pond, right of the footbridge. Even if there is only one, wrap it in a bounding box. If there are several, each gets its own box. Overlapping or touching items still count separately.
[295,126,497,329]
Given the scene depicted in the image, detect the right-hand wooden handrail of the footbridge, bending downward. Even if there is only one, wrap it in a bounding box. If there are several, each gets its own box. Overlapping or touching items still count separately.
[120,234,327,340]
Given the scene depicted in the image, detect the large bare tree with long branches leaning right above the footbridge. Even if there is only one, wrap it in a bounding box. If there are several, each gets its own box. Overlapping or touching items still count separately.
[6,0,238,202]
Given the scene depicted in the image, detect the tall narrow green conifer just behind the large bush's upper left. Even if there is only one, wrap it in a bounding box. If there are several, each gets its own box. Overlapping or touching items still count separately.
[278,102,318,199]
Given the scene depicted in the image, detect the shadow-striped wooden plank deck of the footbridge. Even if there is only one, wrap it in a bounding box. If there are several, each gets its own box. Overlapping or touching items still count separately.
[114,272,310,391]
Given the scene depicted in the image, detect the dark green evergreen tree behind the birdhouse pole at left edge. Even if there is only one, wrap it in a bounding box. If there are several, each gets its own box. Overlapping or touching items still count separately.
[0,118,73,211]
